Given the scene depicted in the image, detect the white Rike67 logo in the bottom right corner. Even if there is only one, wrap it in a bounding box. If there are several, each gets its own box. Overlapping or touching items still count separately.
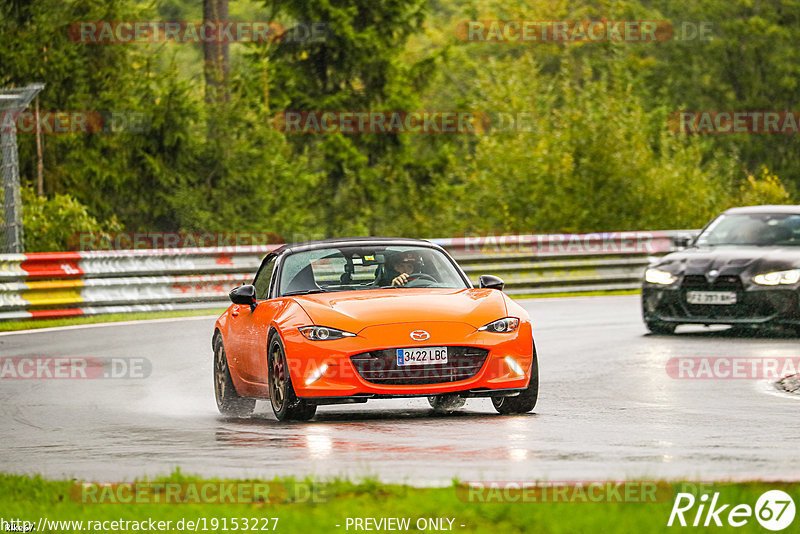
[667,490,795,531]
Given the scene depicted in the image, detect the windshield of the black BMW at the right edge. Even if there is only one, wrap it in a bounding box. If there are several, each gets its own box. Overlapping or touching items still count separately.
[697,213,800,247]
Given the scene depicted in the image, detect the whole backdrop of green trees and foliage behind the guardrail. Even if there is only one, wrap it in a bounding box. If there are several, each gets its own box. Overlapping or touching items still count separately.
[0,0,800,250]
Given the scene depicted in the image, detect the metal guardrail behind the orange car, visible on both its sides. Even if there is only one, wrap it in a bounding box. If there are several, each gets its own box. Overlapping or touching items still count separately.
[0,230,696,321]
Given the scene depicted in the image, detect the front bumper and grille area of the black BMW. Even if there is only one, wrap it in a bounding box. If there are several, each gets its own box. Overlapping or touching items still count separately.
[642,283,800,325]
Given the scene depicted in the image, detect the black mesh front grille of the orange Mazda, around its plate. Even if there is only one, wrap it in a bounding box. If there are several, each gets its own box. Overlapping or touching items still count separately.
[350,347,489,386]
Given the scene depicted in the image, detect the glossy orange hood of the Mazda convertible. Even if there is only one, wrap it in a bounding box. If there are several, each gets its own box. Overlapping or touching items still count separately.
[292,288,507,333]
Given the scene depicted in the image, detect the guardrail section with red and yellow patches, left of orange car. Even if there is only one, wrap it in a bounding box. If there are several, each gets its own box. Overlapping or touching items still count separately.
[0,245,279,320]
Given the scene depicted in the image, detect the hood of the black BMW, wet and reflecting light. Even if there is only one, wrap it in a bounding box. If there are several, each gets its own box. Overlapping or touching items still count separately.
[653,246,800,276]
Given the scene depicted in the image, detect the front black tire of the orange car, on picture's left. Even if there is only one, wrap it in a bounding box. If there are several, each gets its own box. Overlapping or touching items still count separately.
[267,333,317,421]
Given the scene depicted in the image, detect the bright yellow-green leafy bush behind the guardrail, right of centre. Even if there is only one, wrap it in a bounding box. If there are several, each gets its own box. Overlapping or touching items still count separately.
[432,50,730,233]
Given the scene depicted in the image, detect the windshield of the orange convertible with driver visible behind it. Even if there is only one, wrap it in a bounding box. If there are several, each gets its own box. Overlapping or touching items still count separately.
[279,246,469,296]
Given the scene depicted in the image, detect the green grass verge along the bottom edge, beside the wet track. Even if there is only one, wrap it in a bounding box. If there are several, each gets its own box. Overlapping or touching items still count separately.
[0,471,800,534]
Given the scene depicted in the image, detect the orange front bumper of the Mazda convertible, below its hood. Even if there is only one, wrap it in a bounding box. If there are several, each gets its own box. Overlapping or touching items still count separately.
[283,322,535,402]
